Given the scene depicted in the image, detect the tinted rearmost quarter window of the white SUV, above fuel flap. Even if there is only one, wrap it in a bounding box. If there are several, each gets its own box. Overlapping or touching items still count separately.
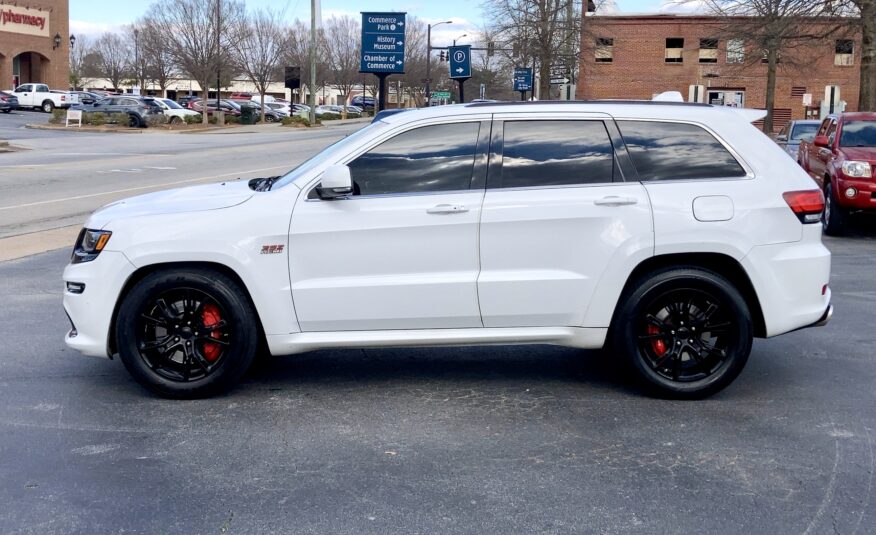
[618,121,745,180]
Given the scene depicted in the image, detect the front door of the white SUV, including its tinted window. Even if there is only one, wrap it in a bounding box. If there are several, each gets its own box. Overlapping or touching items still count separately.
[289,120,490,331]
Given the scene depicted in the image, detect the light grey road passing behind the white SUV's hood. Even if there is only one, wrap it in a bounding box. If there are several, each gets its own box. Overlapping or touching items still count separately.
[0,112,363,238]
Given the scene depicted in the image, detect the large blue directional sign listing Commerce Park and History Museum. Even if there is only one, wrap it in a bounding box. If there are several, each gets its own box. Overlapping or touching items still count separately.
[359,12,406,74]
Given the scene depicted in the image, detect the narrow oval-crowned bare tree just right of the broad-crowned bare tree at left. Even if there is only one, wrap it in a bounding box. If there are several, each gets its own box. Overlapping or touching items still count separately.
[234,9,288,122]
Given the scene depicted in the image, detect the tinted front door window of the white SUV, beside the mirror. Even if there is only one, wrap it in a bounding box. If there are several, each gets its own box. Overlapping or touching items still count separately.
[350,123,480,195]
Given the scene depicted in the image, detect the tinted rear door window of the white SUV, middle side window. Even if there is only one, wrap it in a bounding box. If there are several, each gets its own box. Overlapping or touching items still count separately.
[502,121,614,188]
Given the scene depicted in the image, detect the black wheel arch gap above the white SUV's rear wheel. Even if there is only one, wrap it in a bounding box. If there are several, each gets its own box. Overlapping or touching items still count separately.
[610,253,767,338]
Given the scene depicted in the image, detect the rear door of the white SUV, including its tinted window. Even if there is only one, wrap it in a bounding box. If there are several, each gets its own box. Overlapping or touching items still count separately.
[478,113,654,327]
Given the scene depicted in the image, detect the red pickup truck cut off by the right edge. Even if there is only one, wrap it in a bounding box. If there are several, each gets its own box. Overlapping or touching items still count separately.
[799,112,876,236]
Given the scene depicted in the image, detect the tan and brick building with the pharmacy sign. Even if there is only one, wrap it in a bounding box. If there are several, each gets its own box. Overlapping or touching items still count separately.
[0,0,70,89]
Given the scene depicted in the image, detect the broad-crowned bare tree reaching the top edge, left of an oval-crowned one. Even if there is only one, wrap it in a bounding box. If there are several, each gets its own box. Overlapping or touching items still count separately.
[148,0,244,124]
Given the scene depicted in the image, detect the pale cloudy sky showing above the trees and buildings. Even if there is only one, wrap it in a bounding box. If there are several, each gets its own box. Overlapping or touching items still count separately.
[70,0,700,43]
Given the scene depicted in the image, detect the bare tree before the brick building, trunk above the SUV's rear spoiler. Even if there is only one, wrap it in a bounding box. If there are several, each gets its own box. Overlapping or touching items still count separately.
[699,0,848,133]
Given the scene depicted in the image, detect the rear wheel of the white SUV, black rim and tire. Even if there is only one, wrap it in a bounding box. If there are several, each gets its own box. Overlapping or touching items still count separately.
[610,267,754,399]
